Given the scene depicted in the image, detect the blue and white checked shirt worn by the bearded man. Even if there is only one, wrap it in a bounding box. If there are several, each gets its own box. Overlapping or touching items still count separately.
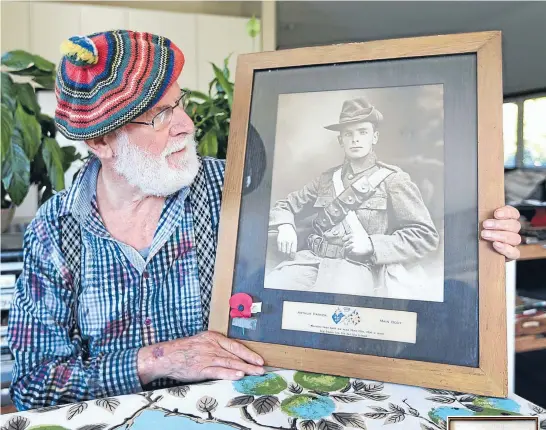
[8,158,224,410]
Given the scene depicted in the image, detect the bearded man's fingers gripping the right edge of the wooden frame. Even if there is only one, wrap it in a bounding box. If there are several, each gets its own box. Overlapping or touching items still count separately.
[481,206,521,260]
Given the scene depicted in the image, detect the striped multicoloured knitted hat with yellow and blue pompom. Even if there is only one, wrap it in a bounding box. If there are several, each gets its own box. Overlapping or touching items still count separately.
[55,30,184,140]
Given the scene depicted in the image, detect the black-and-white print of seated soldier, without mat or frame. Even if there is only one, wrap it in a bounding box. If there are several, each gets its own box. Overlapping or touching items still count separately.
[264,85,444,302]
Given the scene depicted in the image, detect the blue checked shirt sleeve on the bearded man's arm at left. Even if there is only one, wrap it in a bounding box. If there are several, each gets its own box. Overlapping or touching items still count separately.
[8,222,142,410]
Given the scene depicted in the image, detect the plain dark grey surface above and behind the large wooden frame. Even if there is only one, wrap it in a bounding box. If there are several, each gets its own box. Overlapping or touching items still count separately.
[277,1,546,95]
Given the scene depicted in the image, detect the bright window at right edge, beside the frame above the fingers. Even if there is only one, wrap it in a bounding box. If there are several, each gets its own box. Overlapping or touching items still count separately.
[503,95,546,169]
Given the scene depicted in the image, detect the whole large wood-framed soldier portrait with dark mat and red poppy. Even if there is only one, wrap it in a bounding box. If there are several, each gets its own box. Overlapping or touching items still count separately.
[209,32,507,396]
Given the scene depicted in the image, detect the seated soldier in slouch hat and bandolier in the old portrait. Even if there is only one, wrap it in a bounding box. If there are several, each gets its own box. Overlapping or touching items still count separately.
[265,98,439,297]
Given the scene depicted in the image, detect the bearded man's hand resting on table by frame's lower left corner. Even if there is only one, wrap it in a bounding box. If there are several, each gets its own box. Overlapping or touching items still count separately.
[137,332,264,385]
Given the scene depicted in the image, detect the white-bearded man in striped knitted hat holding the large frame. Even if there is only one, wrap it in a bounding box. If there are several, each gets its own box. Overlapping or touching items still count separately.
[9,31,519,410]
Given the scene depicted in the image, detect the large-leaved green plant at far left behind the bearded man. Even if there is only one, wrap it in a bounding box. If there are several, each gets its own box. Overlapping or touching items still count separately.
[1,50,80,231]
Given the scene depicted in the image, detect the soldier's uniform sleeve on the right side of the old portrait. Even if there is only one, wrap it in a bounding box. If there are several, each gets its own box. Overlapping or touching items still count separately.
[370,172,440,264]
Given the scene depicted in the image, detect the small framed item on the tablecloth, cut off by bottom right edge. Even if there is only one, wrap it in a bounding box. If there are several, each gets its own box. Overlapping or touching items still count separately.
[447,416,538,430]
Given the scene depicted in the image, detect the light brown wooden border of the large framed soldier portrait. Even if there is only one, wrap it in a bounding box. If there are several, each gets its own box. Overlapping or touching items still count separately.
[209,32,508,397]
